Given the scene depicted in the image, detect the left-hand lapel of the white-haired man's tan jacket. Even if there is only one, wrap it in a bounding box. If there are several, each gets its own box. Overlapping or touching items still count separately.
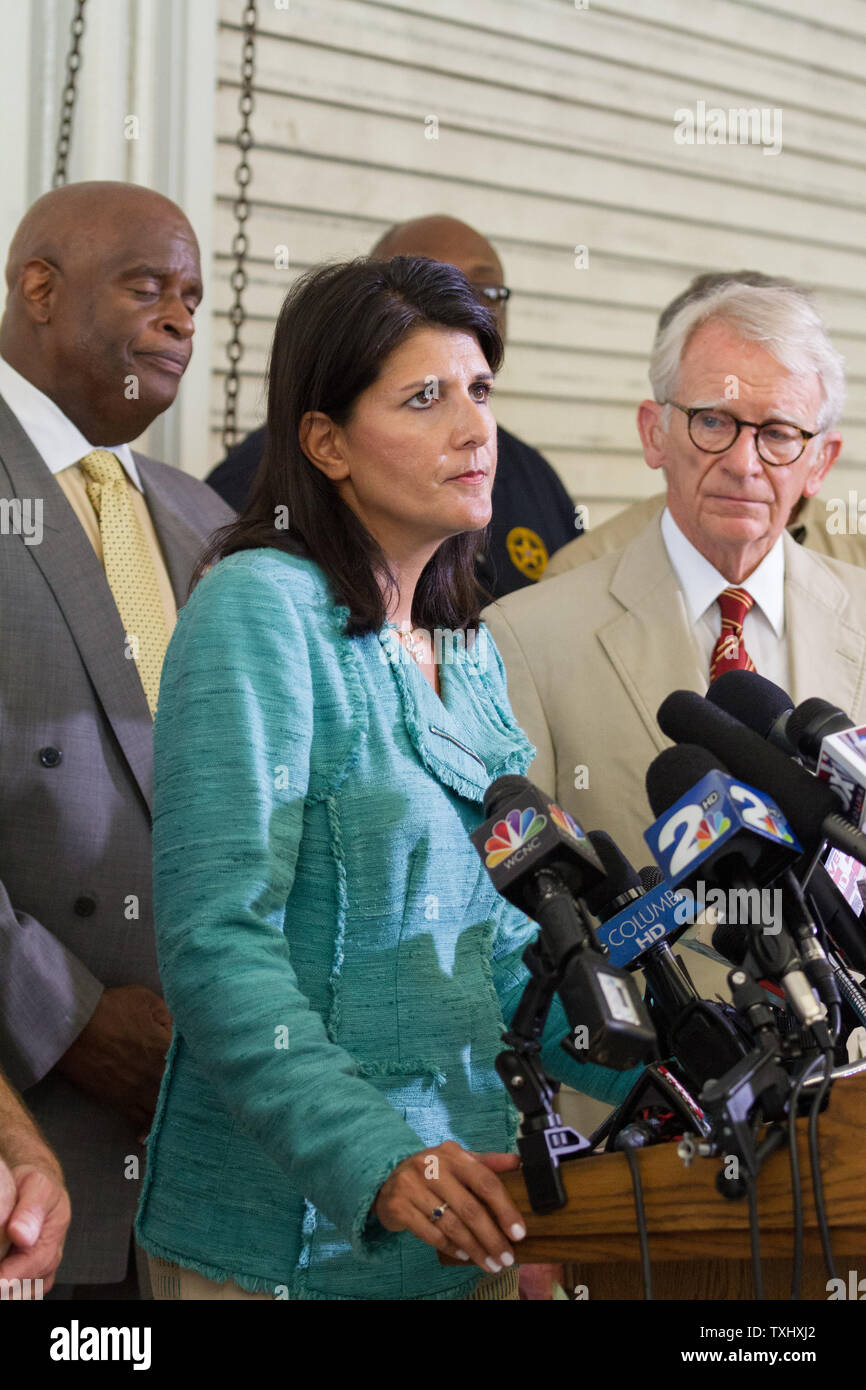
[598,517,708,751]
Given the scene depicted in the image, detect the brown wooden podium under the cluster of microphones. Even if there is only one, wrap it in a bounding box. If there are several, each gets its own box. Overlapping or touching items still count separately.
[489,1074,866,1300]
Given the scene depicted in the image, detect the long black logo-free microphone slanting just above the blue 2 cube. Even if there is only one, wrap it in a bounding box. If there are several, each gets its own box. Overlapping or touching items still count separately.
[657,691,866,859]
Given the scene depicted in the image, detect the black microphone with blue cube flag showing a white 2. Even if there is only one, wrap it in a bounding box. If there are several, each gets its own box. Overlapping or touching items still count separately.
[645,750,827,1026]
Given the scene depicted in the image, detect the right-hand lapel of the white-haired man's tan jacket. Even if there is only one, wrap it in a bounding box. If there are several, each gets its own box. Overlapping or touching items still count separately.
[784,535,866,720]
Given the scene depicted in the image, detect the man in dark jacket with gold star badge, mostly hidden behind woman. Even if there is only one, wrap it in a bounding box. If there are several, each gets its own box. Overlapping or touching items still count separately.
[207,215,581,598]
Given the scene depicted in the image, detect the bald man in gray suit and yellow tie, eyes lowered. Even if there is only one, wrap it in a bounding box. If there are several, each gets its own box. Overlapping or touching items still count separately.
[0,183,234,1297]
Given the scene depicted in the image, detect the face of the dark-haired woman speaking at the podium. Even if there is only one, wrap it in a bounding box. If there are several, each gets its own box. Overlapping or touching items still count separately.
[316,328,496,557]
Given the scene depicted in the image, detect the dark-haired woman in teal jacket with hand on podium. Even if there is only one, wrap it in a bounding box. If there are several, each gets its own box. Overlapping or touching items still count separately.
[136,257,632,1298]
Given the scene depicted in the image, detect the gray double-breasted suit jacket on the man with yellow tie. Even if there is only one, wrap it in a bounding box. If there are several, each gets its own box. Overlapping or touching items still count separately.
[0,396,234,1283]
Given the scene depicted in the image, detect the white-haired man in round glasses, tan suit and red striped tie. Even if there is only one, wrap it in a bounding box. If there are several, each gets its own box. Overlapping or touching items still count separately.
[484,272,866,865]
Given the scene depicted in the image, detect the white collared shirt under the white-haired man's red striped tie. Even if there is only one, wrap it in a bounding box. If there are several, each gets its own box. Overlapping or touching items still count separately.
[662,507,788,689]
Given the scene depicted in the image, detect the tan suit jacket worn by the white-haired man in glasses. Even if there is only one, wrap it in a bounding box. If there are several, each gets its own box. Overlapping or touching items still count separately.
[484,517,866,867]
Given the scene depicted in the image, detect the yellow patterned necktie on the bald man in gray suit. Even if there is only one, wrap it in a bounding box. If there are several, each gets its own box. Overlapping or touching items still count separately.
[78,449,168,714]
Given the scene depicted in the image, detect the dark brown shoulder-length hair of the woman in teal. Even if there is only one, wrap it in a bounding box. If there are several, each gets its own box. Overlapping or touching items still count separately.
[190,256,503,635]
